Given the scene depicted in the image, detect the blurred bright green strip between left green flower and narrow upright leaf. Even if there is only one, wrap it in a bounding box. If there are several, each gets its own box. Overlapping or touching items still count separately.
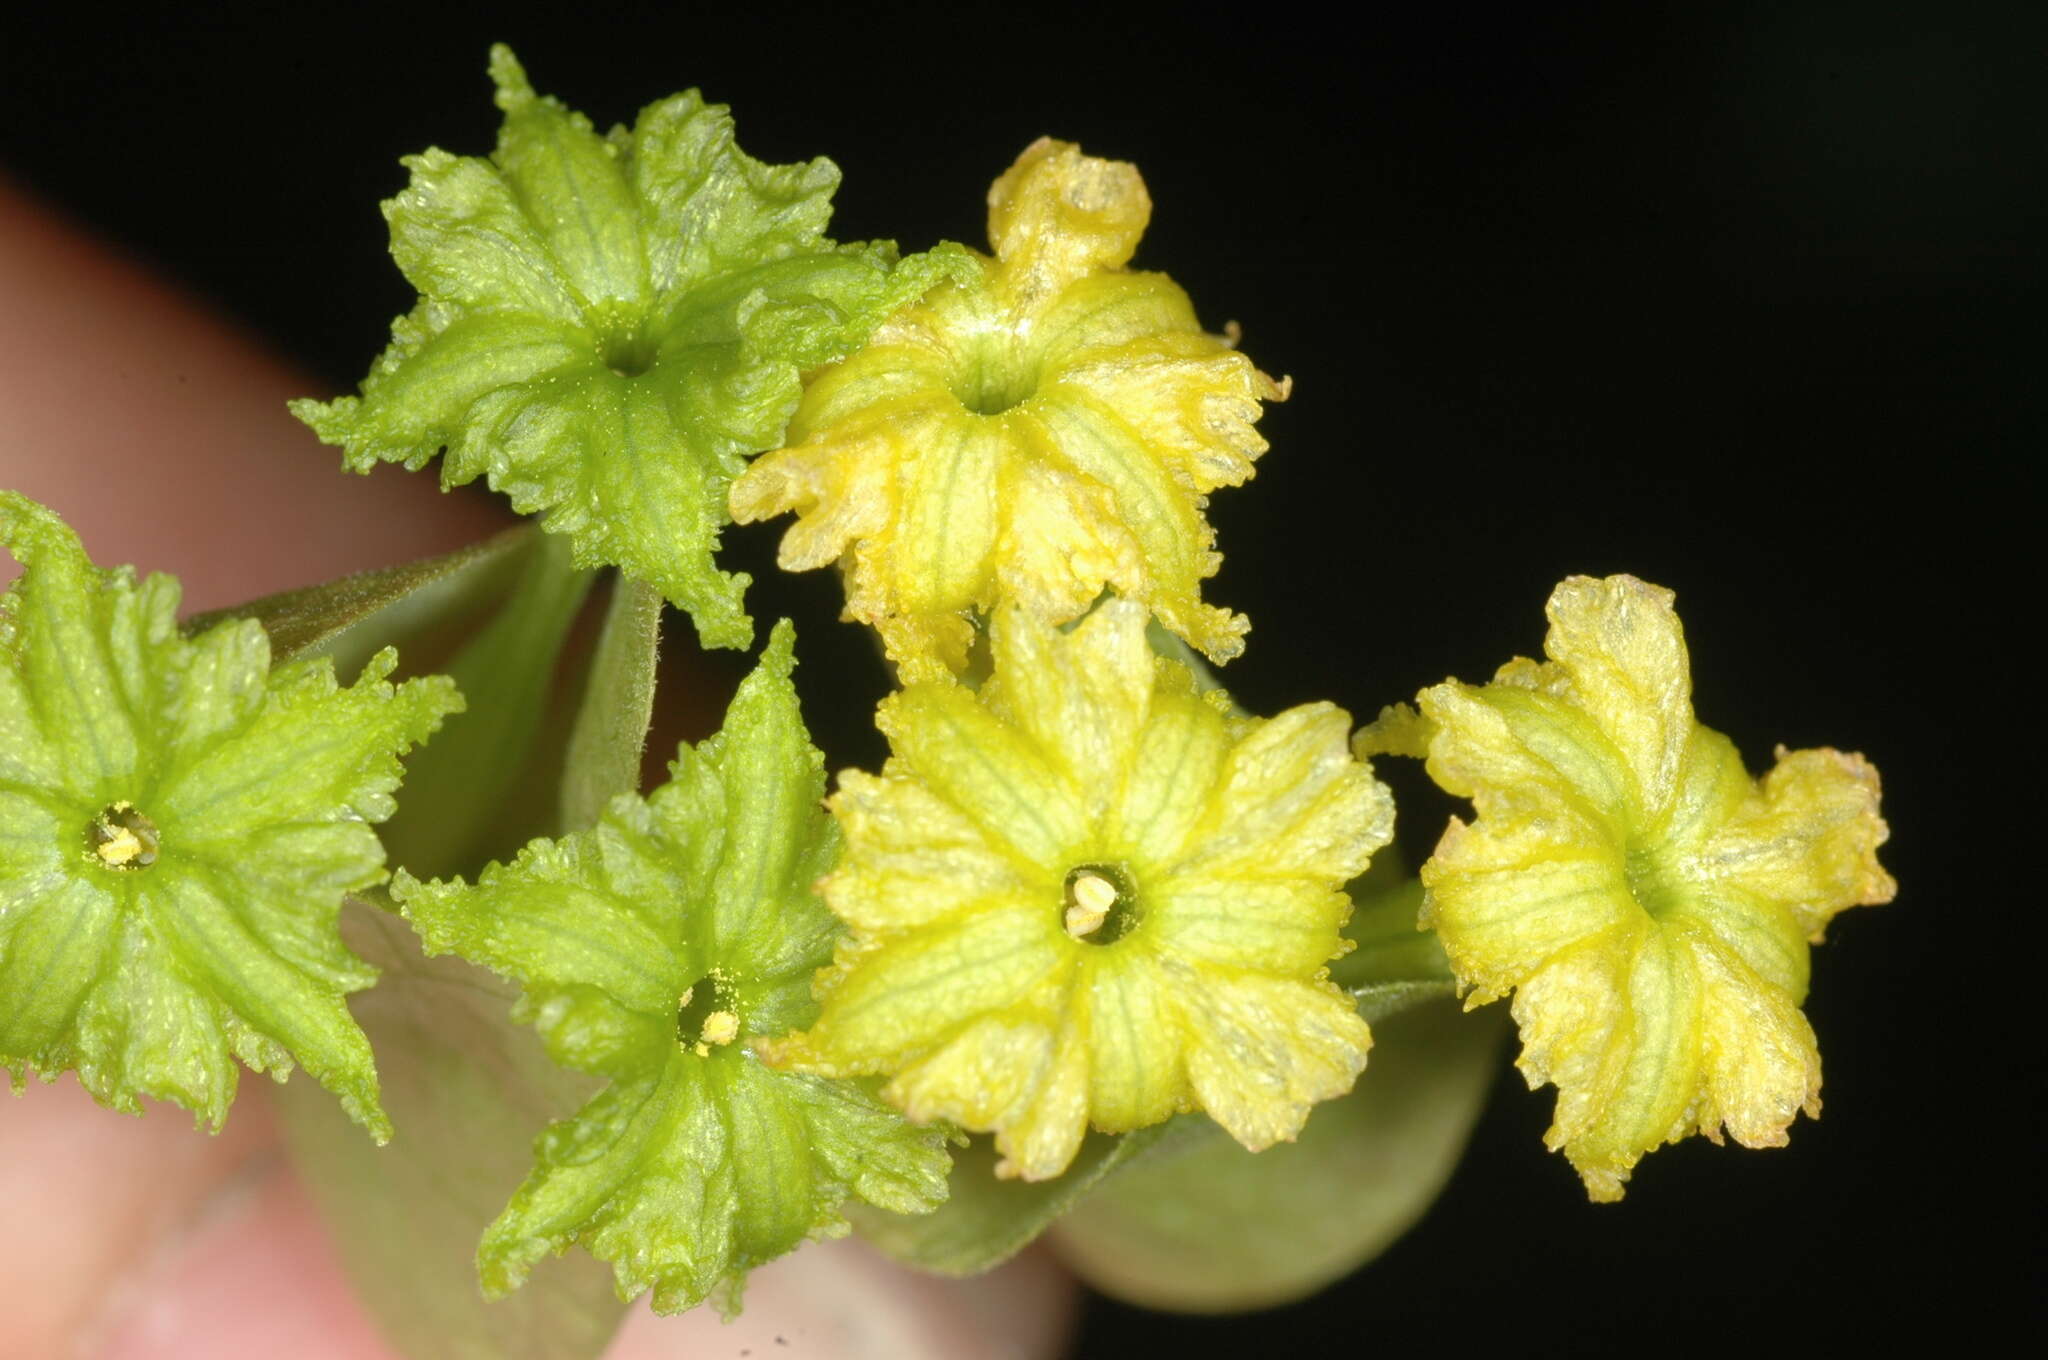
[385,537,594,875]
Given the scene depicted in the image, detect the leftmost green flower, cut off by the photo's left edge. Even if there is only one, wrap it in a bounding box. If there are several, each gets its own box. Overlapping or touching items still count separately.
[0,492,461,1141]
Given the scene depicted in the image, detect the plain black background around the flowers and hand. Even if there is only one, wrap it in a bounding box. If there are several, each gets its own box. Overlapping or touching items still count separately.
[0,4,2048,1356]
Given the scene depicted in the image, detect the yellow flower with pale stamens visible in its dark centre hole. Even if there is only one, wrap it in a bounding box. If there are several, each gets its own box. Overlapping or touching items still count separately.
[766,600,1393,1180]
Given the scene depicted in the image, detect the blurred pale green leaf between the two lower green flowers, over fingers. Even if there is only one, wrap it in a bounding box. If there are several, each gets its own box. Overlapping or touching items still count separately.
[276,901,625,1360]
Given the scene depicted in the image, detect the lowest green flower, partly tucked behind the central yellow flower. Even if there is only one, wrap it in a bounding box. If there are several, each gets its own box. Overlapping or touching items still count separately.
[395,623,948,1313]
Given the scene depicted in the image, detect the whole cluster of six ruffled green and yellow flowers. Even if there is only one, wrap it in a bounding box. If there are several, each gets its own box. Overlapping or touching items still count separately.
[0,47,1894,1311]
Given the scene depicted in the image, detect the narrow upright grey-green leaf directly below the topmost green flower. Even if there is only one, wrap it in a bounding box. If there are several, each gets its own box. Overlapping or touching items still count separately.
[561,576,662,832]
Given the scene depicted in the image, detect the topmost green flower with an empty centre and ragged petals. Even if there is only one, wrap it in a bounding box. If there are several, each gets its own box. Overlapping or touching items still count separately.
[293,47,948,647]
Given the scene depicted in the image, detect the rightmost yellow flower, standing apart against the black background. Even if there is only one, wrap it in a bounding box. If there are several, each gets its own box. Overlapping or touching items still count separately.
[1358,576,1896,1200]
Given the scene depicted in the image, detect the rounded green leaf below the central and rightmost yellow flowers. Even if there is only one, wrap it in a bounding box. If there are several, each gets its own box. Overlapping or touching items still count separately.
[1051,999,1503,1313]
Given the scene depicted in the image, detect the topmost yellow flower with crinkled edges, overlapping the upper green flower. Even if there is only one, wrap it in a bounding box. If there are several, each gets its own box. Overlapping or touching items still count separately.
[731,137,1286,680]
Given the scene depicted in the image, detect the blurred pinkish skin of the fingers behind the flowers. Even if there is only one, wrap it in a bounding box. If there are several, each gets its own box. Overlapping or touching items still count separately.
[0,180,1073,1360]
